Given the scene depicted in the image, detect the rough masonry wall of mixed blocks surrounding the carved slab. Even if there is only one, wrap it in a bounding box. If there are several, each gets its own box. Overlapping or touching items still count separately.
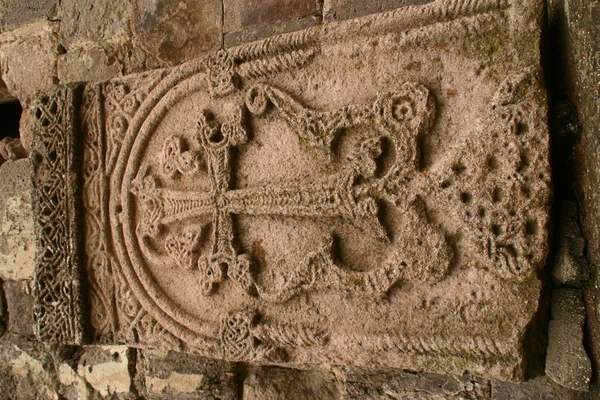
[0,0,600,400]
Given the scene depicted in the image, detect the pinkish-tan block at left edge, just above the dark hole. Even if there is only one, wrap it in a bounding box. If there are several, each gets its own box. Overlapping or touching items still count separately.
[0,22,58,103]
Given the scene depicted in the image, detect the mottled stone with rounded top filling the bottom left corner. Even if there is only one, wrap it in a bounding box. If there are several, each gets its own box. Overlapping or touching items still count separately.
[0,333,59,400]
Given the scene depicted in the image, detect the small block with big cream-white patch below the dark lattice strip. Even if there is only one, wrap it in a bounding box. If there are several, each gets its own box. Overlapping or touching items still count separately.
[75,346,132,397]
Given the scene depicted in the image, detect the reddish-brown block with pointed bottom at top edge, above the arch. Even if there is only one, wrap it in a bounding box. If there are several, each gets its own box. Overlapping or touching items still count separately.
[131,0,222,65]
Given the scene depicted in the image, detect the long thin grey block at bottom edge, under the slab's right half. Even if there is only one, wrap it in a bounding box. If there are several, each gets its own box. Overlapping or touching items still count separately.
[334,368,492,400]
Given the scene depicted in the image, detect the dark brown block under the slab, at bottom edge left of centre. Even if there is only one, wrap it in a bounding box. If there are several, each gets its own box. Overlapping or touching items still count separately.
[242,367,340,400]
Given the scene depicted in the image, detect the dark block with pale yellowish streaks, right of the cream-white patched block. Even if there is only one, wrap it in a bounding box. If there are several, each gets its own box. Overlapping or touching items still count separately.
[136,350,238,400]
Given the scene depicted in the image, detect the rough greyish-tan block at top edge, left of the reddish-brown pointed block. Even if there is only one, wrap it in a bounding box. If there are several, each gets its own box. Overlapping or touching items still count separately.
[58,0,130,51]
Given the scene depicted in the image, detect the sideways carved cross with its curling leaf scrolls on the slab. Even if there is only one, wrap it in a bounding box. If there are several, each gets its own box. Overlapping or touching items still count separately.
[132,84,434,301]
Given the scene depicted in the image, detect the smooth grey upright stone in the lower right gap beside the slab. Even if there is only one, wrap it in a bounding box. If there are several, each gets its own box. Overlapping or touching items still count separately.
[546,289,592,390]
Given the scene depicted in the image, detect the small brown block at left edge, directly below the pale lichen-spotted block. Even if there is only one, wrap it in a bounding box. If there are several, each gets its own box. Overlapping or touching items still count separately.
[4,280,34,336]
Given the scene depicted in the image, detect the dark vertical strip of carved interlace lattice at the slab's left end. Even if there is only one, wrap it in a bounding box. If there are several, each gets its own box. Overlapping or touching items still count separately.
[31,85,85,344]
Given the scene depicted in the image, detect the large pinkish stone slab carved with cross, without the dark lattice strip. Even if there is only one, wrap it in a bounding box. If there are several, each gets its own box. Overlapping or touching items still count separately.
[31,0,550,379]
